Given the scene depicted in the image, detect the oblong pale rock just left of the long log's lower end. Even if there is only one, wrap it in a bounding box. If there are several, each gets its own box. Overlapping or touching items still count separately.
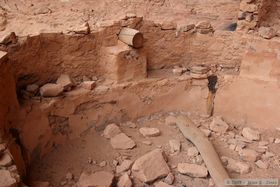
[177,163,208,177]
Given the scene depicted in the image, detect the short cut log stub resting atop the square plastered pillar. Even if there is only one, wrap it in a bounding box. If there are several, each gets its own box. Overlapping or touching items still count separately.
[119,27,144,48]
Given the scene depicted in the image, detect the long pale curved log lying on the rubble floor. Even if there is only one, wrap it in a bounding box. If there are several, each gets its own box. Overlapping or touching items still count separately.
[171,116,233,187]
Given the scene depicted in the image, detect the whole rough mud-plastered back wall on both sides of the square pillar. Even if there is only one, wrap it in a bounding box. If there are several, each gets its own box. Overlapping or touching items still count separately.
[9,18,246,87]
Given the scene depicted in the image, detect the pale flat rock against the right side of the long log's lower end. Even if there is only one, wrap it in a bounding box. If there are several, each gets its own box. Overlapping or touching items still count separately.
[223,157,250,174]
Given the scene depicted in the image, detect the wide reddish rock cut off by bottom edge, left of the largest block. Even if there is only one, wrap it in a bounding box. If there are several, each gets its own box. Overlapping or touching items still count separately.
[78,171,114,187]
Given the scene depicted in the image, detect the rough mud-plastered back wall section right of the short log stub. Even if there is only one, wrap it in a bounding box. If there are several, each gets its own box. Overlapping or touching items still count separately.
[140,22,246,69]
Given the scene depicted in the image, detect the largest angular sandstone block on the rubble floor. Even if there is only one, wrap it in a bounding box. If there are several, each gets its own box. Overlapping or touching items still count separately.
[132,149,170,183]
